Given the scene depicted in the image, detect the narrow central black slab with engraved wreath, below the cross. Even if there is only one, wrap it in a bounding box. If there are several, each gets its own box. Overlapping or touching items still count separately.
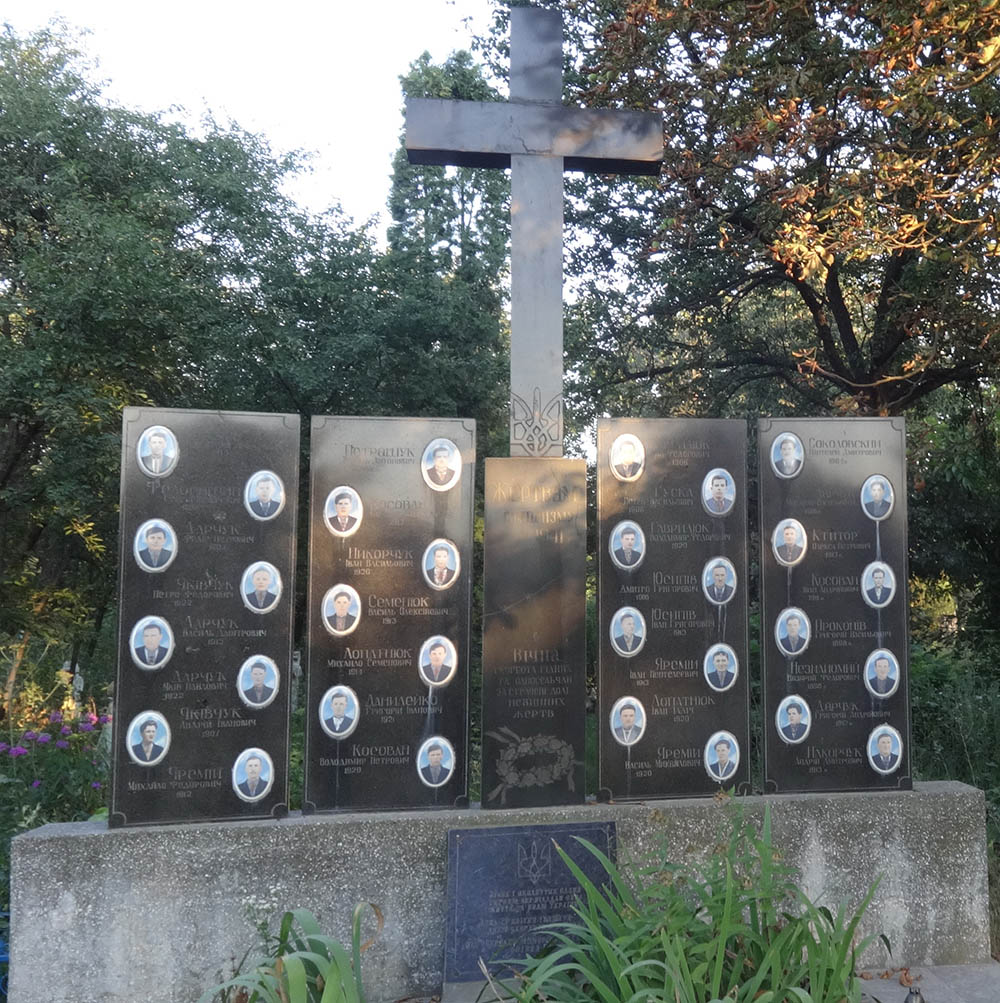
[482,457,587,808]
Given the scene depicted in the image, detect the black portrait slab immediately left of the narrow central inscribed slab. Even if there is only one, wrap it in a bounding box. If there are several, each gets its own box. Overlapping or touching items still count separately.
[303,417,475,812]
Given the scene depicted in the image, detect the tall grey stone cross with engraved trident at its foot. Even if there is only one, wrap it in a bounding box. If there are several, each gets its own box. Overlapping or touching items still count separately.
[406,7,663,456]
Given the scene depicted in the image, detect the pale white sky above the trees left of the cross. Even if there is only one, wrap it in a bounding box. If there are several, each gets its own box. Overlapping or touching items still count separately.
[3,0,490,230]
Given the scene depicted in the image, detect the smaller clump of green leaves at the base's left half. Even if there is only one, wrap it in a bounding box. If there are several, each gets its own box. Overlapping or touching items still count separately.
[201,903,382,1003]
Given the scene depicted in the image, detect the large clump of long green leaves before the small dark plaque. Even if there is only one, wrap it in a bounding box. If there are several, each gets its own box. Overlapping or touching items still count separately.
[495,812,875,1003]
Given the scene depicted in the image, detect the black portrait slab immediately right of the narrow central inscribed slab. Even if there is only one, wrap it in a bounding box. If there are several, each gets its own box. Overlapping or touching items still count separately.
[598,418,749,800]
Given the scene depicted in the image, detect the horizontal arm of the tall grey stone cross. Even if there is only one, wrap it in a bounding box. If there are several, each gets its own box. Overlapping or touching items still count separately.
[406,97,663,176]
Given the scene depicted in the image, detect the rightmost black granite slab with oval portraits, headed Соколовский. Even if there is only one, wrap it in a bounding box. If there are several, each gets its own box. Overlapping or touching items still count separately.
[757,418,912,792]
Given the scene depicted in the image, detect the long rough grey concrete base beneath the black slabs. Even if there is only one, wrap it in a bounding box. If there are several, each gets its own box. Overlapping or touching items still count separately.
[9,782,989,1003]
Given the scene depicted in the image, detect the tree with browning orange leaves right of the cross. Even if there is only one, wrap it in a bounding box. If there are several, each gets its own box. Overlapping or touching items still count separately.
[497,0,1000,414]
